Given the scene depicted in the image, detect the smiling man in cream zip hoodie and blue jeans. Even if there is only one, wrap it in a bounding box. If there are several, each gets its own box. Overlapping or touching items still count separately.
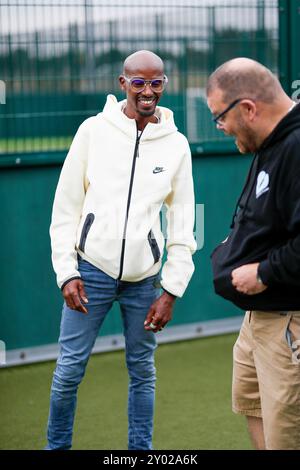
[46,51,196,449]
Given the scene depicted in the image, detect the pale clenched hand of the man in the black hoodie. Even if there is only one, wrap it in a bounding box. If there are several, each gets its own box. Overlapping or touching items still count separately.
[231,263,268,295]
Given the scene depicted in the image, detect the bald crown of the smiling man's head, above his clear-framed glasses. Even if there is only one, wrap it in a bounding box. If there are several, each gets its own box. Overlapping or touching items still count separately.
[123,50,164,75]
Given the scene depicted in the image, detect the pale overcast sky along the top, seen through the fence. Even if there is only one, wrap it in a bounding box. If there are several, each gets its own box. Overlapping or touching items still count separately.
[0,0,277,34]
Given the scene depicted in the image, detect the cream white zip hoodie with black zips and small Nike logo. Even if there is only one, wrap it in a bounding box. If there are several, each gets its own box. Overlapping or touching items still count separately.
[50,95,196,297]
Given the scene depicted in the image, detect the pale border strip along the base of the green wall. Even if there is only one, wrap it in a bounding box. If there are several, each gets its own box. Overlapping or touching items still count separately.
[1,316,243,368]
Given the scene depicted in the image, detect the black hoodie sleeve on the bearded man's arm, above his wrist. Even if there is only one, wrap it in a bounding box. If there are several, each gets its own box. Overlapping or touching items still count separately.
[258,134,300,286]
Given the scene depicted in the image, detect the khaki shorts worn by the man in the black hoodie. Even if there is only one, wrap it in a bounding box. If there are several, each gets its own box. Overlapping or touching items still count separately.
[232,311,300,450]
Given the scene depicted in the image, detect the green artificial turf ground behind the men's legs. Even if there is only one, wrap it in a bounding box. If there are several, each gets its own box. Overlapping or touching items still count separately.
[0,335,251,449]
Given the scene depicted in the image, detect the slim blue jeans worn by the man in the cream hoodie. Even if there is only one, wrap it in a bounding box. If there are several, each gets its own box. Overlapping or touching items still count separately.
[46,258,160,450]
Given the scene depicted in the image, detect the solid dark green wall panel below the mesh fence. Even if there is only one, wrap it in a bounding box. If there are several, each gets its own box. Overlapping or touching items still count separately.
[0,155,249,350]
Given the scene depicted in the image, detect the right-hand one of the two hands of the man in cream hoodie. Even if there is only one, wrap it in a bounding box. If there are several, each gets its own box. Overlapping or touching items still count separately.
[144,292,176,333]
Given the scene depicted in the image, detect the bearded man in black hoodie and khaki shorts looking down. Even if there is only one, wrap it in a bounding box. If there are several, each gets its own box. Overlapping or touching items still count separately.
[207,58,300,449]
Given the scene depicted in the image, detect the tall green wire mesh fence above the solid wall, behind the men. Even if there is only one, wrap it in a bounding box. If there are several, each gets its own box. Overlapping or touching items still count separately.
[0,0,278,155]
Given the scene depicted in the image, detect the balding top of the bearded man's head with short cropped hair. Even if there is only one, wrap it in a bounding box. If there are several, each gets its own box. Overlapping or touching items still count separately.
[206,57,284,104]
